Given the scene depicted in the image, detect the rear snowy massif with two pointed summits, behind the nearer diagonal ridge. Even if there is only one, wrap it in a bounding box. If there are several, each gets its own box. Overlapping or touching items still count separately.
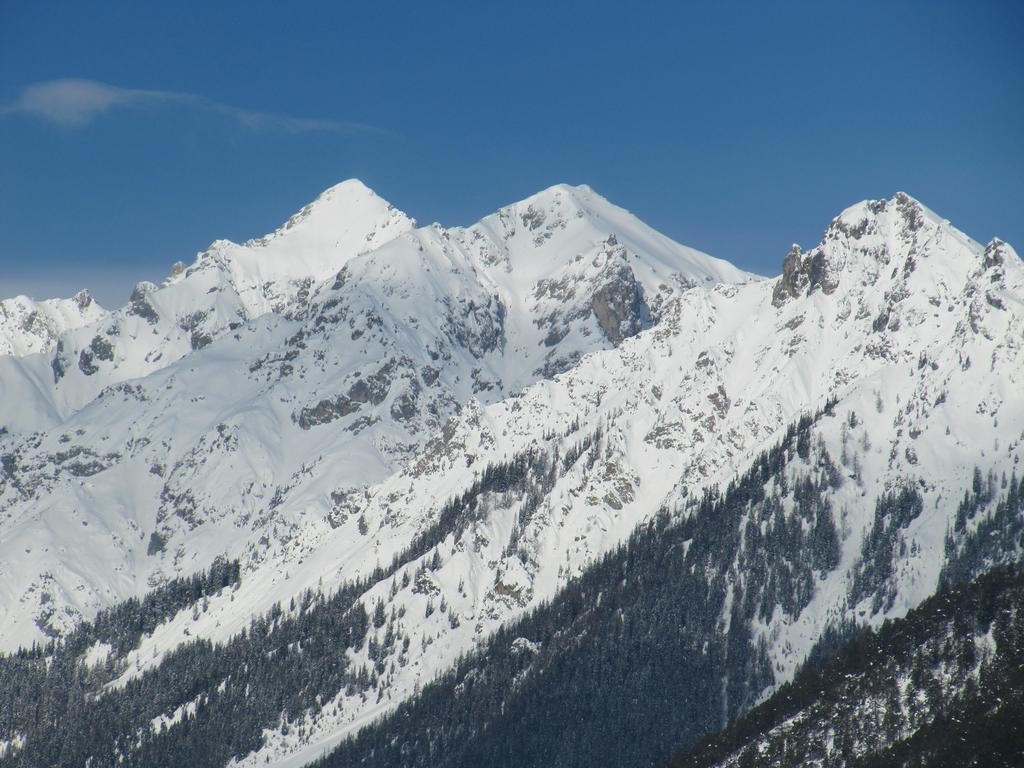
[0,182,751,646]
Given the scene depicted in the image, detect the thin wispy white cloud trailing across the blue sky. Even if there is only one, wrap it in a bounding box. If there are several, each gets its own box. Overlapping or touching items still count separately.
[0,79,385,134]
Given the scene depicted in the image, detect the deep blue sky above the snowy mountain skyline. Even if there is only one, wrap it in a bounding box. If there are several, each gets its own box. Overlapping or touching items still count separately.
[0,0,1024,306]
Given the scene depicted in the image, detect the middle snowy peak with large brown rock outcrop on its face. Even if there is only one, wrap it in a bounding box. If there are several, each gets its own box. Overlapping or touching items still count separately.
[451,184,752,382]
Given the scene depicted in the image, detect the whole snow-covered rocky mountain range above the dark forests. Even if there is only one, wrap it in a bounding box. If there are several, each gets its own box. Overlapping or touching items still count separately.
[0,182,1024,765]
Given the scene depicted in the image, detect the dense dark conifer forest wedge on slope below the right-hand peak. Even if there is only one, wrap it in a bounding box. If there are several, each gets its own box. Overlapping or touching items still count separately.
[299,421,1024,768]
